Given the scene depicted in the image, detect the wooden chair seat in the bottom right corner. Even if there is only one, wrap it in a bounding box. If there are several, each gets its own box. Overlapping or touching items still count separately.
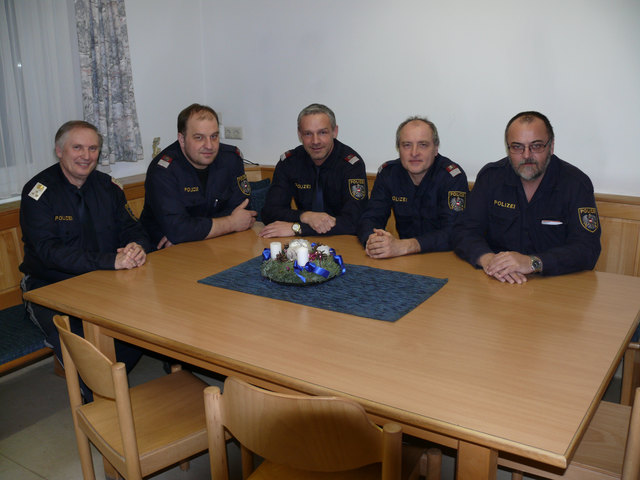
[498,401,631,480]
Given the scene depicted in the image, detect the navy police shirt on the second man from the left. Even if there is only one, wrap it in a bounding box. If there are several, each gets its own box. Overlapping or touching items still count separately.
[140,141,251,246]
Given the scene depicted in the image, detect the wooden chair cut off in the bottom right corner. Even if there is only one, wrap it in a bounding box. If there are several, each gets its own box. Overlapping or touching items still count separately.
[498,388,640,480]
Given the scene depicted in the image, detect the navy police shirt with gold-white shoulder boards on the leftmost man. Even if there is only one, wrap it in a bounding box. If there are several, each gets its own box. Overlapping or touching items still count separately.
[20,163,150,284]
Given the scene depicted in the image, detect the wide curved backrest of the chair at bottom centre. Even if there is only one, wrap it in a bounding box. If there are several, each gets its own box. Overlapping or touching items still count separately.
[205,377,402,479]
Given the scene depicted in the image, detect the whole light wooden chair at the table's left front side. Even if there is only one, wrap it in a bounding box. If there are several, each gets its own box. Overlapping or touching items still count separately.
[54,315,207,480]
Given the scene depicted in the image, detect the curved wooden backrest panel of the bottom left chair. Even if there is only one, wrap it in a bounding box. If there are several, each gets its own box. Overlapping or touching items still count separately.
[53,315,115,400]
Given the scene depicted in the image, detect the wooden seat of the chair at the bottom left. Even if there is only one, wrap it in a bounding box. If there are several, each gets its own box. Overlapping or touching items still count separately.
[78,370,207,476]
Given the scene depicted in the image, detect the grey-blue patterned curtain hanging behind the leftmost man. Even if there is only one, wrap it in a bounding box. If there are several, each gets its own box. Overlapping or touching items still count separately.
[75,0,143,165]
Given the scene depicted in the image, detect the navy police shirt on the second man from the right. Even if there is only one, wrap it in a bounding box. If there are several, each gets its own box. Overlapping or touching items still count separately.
[358,154,469,252]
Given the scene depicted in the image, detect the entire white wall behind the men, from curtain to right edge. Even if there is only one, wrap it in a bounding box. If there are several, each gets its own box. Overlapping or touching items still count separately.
[126,0,640,195]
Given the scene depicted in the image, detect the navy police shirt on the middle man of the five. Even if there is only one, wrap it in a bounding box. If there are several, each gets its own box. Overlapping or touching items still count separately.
[262,140,368,235]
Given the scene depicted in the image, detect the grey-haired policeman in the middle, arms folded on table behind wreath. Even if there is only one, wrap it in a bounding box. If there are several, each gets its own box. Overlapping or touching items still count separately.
[260,103,368,238]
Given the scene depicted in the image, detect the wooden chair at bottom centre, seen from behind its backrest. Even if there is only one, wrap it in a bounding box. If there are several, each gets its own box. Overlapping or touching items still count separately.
[205,377,439,480]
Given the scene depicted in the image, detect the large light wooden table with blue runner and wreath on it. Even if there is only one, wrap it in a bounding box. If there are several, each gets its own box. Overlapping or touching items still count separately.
[26,230,640,480]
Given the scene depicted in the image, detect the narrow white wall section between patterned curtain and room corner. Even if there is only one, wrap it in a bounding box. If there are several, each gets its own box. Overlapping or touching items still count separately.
[120,0,207,177]
